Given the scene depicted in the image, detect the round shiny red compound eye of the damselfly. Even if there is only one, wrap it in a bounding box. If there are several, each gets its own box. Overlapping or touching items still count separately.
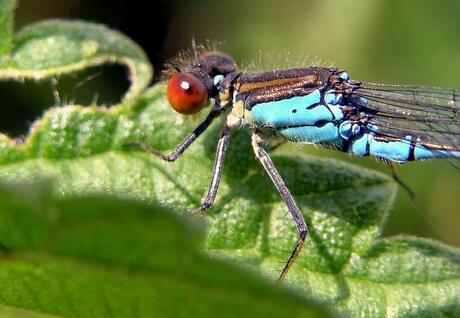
[166,73,208,115]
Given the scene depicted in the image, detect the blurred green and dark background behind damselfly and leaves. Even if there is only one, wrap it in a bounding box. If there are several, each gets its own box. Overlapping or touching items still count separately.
[0,0,460,246]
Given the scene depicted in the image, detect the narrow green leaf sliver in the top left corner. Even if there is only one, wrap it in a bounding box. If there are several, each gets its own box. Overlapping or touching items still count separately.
[0,0,16,57]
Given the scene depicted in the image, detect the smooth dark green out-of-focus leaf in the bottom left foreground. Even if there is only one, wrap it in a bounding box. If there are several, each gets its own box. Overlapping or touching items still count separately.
[0,184,330,317]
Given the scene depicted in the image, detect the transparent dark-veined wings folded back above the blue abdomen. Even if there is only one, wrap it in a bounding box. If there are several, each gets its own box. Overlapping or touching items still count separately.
[352,83,460,151]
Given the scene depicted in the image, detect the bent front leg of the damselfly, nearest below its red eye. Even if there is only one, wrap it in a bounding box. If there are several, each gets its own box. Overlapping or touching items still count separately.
[123,110,222,162]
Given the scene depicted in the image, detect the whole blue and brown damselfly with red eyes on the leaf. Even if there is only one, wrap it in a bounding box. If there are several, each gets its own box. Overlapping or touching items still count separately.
[128,52,460,280]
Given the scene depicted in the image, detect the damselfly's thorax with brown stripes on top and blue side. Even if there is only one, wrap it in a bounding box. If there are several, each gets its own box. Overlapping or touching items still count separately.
[230,67,358,130]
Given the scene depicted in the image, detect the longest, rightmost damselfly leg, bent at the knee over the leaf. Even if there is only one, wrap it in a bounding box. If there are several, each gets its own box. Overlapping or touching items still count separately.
[252,132,308,282]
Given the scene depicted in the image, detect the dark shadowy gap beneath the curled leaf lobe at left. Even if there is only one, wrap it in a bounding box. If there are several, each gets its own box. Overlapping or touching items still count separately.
[0,64,130,138]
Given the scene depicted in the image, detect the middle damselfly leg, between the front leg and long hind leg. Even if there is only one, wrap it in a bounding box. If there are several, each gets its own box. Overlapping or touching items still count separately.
[190,125,230,214]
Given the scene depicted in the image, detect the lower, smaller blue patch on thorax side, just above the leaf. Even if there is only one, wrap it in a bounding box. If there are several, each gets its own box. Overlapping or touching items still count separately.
[279,123,340,144]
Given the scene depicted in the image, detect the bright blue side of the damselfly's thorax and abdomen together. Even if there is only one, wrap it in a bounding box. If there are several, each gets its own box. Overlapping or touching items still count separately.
[246,89,460,162]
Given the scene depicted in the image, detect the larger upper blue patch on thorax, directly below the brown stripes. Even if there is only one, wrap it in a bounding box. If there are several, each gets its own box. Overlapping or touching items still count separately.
[252,90,343,129]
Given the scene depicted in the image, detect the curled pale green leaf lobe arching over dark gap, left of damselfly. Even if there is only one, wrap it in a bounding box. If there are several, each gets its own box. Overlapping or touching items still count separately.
[0,19,152,98]
